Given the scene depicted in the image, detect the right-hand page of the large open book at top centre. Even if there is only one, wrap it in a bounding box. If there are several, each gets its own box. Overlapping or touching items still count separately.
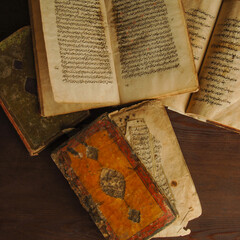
[104,0,198,103]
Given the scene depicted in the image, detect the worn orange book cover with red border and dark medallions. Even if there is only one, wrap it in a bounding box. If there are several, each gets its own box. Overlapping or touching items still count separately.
[52,115,176,240]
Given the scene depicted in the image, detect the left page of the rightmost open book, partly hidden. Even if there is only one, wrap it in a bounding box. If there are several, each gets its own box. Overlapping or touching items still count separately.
[163,0,222,113]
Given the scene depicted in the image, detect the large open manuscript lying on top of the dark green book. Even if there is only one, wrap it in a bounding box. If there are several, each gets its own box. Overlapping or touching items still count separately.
[29,0,198,116]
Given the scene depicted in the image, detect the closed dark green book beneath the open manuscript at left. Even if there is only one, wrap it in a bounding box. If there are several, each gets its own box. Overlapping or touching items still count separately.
[0,27,88,155]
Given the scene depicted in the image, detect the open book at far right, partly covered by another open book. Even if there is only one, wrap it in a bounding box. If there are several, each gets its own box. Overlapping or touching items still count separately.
[164,0,240,131]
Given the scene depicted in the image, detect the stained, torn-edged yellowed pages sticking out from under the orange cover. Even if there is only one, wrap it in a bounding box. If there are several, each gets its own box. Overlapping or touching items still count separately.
[110,100,202,237]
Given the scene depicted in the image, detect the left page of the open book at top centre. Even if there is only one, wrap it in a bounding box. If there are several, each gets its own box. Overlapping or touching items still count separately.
[39,0,119,104]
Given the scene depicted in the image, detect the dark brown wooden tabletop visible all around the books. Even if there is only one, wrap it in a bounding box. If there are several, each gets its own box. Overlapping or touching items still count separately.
[0,0,240,240]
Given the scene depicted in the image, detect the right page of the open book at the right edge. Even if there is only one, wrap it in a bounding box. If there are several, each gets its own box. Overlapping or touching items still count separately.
[187,0,240,129]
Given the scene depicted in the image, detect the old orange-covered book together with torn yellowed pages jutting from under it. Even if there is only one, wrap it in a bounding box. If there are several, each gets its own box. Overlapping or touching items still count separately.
[52,101,201,240]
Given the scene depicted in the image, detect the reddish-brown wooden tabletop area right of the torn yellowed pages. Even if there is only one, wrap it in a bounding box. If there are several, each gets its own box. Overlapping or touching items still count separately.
[161,111,240,240]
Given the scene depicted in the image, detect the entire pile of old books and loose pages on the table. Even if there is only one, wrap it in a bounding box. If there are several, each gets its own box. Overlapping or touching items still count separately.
[0,0,240,240]
